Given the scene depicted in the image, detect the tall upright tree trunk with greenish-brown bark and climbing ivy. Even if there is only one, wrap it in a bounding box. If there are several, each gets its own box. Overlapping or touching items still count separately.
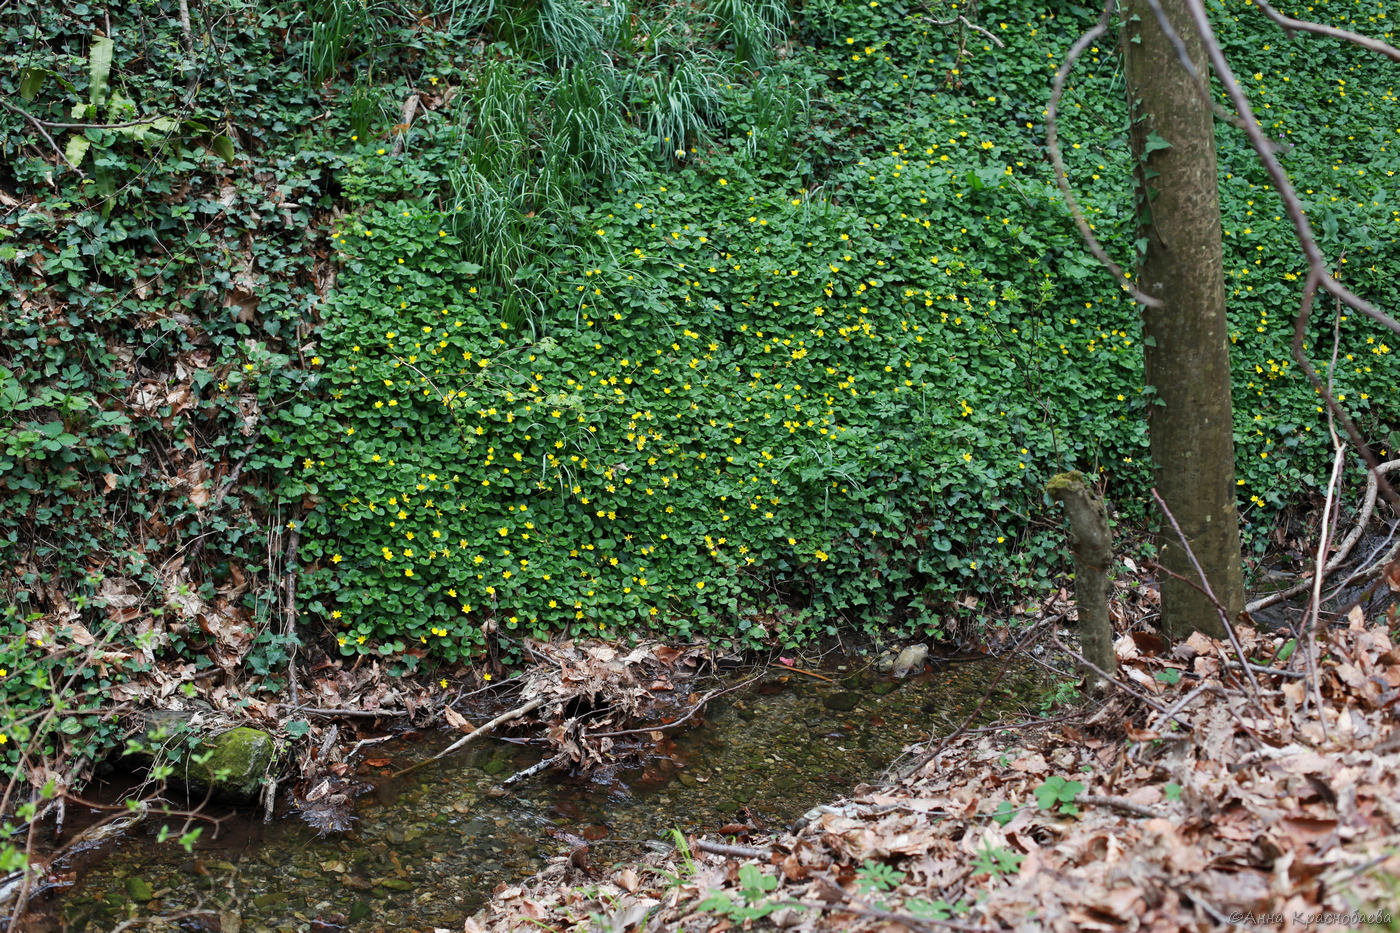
[1123,0,1245,639]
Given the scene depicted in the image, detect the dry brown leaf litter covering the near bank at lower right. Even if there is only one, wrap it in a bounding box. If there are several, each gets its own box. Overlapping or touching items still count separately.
[459,611,1400,933]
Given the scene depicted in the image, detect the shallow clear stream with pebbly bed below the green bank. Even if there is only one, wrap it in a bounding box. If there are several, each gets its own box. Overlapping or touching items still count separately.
[29,660,1037,933]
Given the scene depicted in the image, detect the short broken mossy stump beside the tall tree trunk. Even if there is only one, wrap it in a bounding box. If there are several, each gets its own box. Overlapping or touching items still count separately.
[1046,472,1117,684]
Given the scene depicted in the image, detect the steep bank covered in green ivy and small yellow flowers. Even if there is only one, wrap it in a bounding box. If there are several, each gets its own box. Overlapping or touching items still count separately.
[0,0,1400,763]
